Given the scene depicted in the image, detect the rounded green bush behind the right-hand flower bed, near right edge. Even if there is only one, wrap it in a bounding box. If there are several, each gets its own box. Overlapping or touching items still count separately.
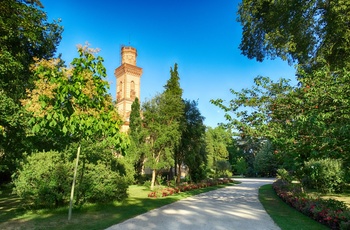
[302,158,345,193]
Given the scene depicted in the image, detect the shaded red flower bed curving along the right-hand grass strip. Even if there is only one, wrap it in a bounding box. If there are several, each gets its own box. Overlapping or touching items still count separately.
[273,180,350,230]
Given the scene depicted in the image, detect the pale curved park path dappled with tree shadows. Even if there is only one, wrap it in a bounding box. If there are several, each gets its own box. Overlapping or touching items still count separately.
[108,178,280,230]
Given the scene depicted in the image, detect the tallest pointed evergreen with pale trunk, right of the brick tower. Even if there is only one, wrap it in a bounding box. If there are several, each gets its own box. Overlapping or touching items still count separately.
[143,64,184,189]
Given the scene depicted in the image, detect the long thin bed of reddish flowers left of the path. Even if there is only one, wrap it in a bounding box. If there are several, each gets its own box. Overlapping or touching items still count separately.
[148,179,233,198]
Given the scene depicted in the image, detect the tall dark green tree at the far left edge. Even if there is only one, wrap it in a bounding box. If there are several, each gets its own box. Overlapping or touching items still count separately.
[0,0,63,180]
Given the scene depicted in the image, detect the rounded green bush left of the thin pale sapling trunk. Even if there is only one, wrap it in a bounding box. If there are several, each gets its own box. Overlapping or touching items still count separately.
[14,151,73,207]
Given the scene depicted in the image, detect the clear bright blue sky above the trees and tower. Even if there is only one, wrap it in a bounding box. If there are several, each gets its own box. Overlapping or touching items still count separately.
[41,0,295,127]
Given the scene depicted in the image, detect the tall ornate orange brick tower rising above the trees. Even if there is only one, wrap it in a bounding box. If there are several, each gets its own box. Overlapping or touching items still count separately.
[114,46,142,132]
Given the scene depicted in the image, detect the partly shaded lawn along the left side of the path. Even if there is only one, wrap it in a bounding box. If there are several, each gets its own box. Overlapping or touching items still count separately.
[0,184,232,230]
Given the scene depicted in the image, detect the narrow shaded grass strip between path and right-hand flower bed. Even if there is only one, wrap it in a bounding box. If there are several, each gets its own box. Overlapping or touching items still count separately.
[259,184,329,230]
